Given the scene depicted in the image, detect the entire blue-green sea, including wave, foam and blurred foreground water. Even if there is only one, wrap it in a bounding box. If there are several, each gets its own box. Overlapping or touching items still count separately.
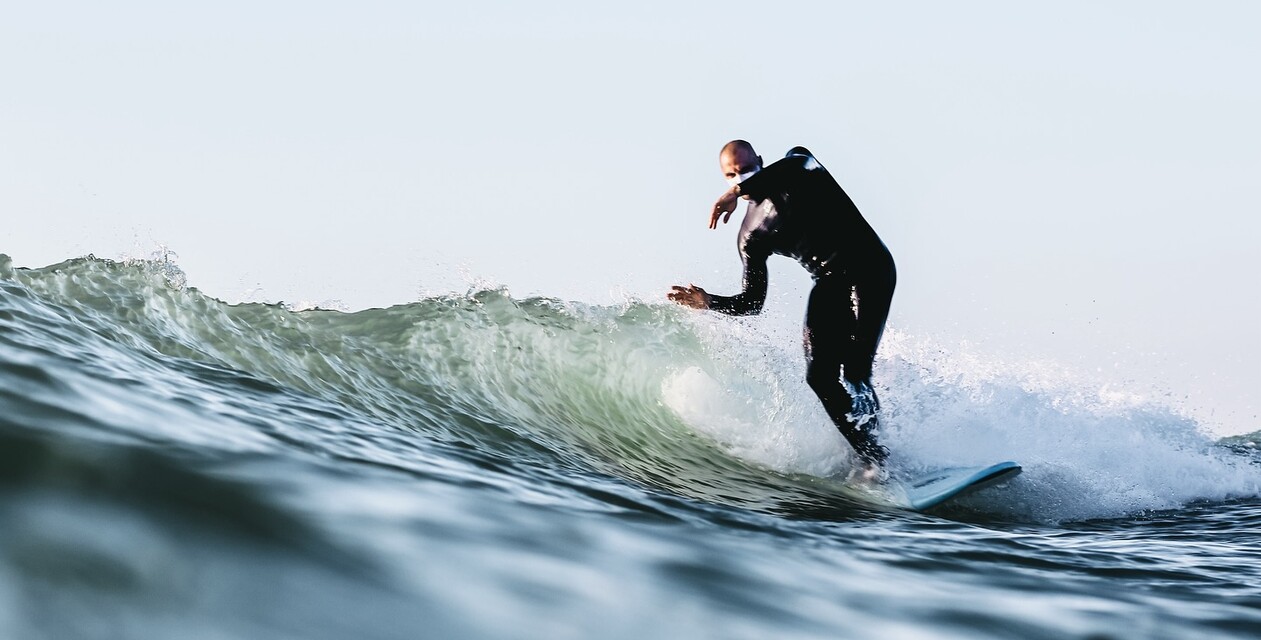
[0,254,1261,639]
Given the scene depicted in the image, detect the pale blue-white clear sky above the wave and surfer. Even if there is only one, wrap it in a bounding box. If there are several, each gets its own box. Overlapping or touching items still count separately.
[0,0,1261,433]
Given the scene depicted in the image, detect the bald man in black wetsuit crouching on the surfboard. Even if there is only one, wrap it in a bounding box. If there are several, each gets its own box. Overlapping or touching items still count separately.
[667,140,897,472]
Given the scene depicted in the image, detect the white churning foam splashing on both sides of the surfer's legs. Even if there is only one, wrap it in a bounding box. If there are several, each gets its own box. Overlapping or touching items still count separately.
[663,319,1261,520]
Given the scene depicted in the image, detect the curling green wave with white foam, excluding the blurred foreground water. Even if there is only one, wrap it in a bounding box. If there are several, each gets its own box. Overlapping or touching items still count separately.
[0,251,1261,520]
